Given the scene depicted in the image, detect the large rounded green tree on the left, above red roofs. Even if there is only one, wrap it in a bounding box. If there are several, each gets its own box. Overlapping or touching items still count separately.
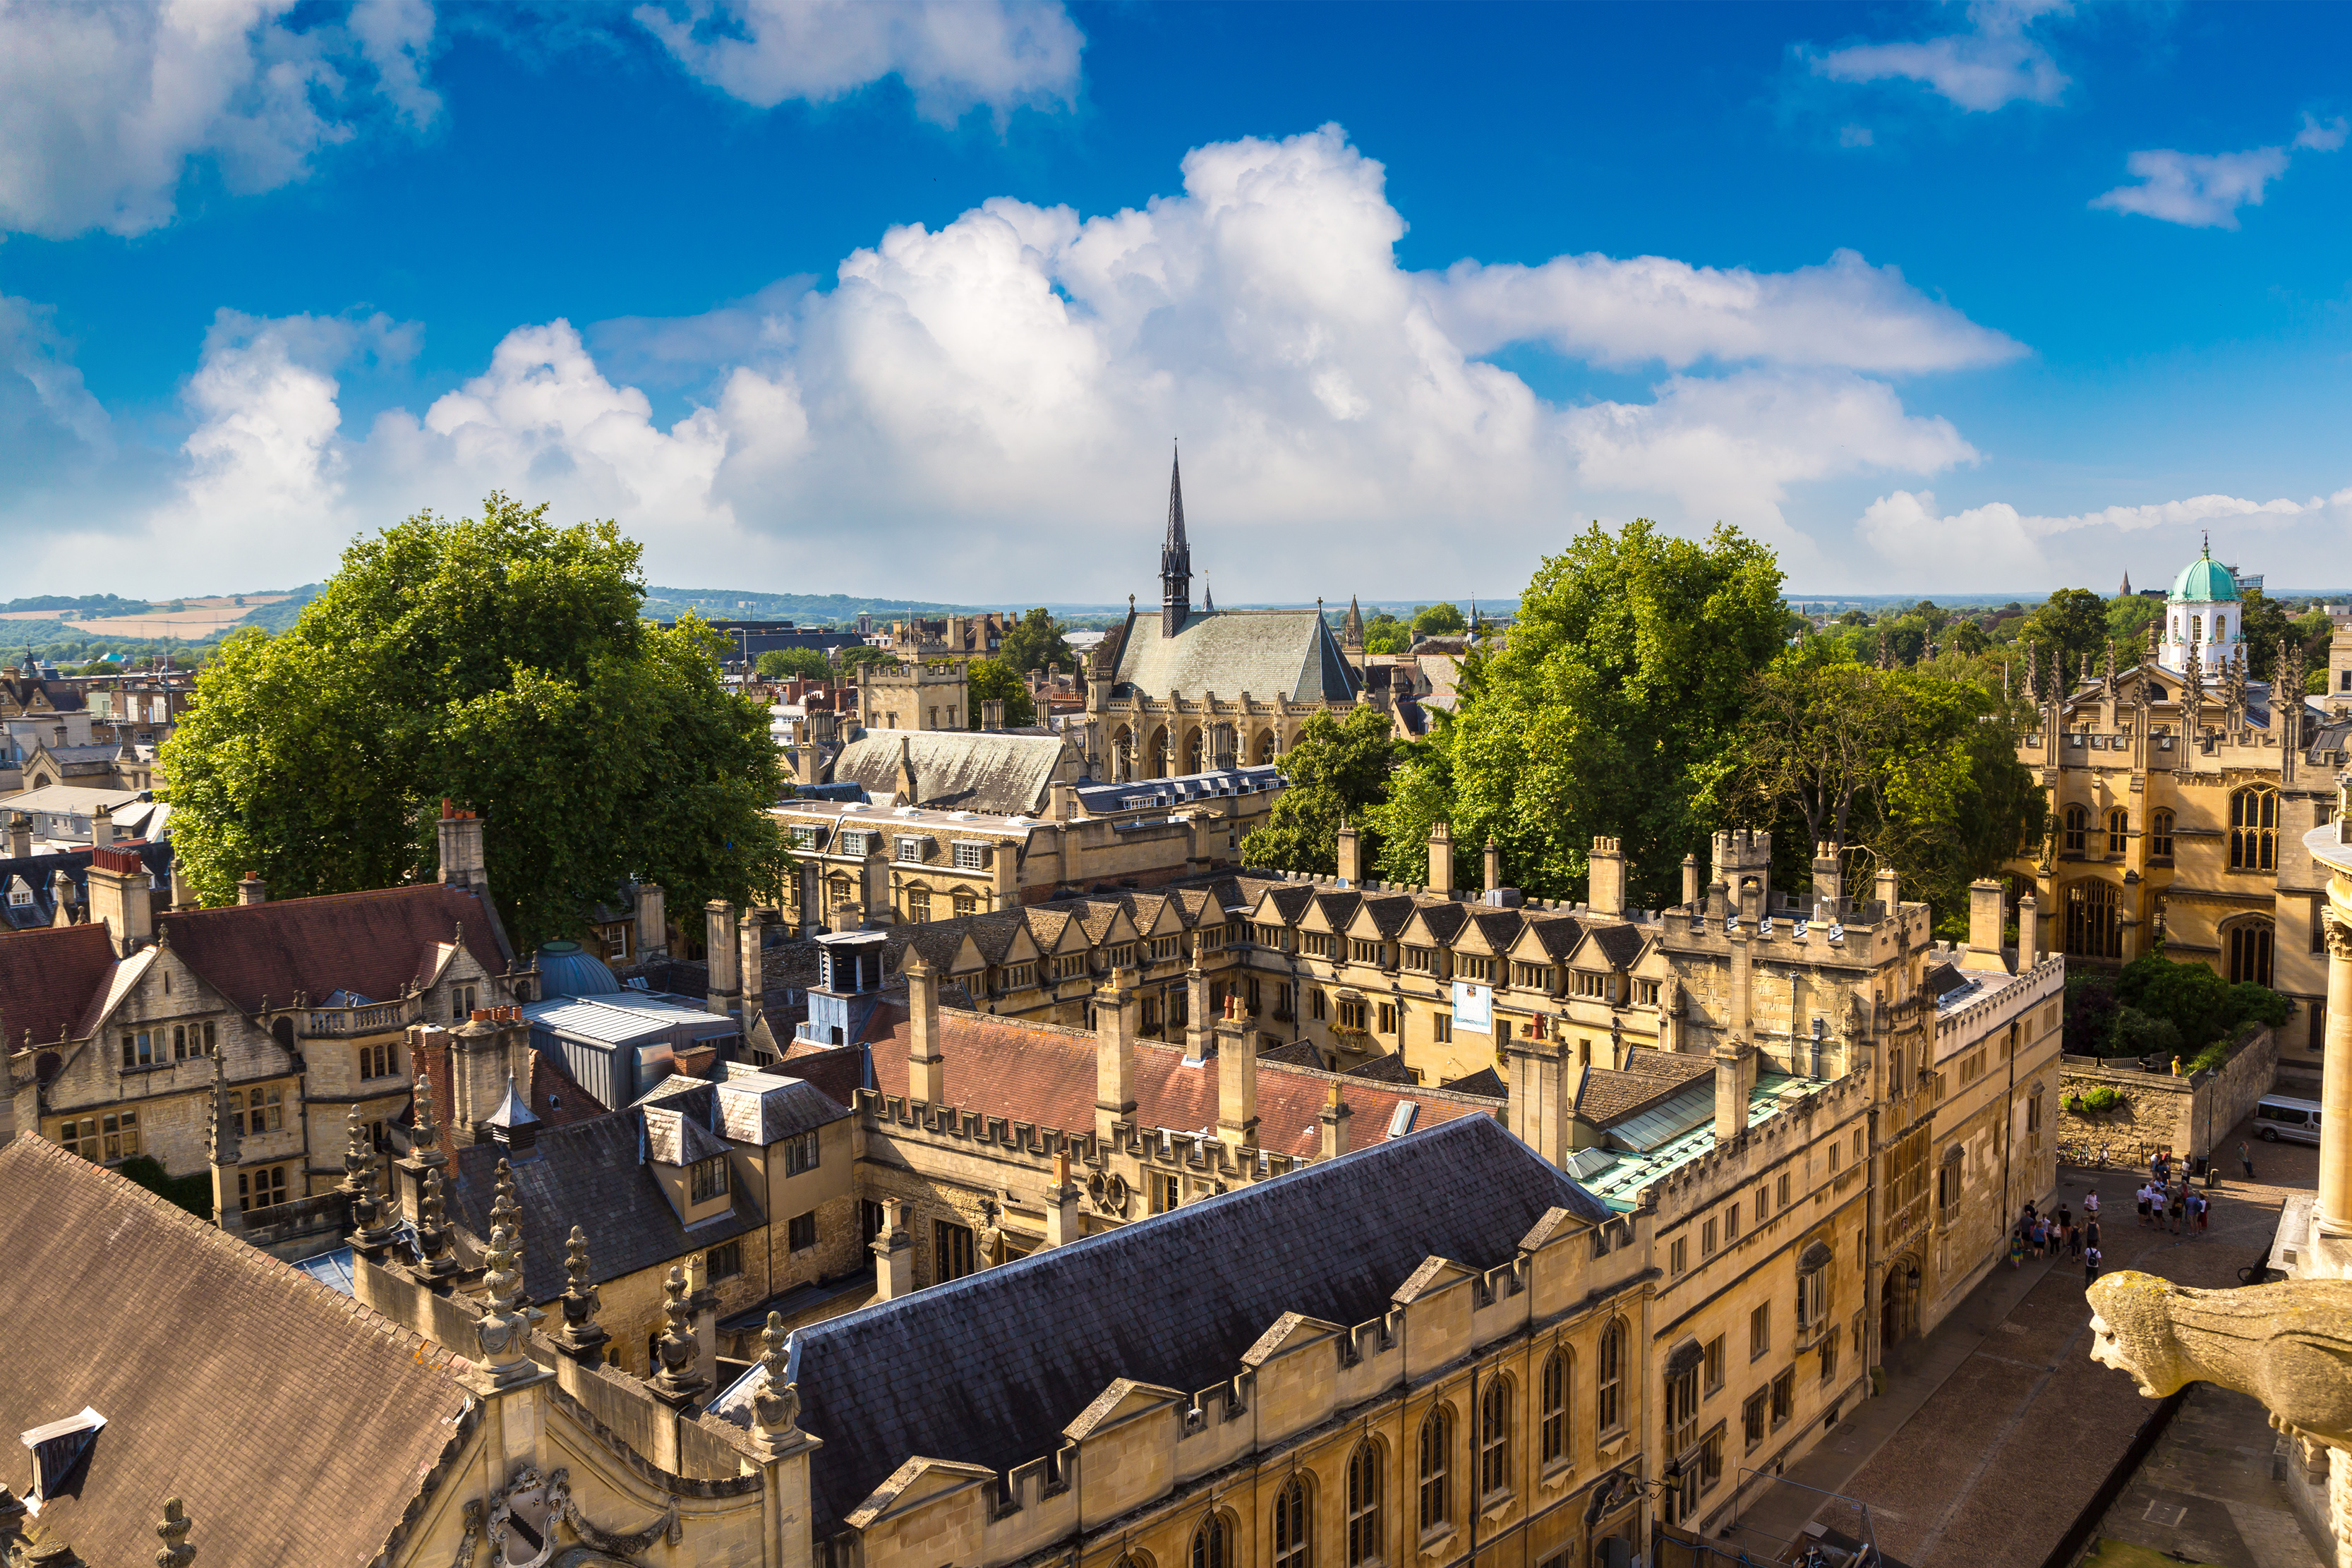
[162,494,790,945]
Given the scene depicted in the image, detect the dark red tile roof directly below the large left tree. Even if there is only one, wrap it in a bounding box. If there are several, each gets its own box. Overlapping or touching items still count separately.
[155,881,506,1013]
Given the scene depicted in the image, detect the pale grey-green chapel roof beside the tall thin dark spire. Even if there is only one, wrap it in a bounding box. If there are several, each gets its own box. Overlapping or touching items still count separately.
[1113,609,1357,703]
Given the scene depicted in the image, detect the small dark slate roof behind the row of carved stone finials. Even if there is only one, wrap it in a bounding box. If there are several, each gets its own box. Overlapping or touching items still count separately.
[452,1112,762,1303]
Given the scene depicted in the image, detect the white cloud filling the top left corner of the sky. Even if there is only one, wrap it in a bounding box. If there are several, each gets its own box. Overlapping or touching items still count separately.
[0,0,440,237]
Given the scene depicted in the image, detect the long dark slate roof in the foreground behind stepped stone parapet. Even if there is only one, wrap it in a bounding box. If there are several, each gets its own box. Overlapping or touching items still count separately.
[761,1116,1609,1540]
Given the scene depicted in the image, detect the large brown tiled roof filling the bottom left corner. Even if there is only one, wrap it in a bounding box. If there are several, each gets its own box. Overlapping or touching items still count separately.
[0,1133,471,1568]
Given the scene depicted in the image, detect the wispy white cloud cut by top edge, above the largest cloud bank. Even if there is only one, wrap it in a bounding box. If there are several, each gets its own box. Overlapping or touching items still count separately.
[635,0,1087,122]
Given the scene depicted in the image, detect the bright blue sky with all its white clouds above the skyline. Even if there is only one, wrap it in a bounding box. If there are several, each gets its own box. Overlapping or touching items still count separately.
[0,0,2352,602]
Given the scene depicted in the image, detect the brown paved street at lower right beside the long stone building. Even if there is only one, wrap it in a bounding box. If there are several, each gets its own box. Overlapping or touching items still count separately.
[1724,1123,2319,1568]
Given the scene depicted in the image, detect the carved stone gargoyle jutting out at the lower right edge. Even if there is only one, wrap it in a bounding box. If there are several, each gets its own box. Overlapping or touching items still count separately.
[2091,1270,2352,1453]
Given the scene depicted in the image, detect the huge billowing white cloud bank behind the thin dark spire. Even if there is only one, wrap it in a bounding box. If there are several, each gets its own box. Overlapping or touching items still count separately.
[9,127,2020,599]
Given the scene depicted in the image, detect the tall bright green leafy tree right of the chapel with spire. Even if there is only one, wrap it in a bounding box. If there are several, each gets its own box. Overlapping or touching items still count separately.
[1413,519,1780,907]
